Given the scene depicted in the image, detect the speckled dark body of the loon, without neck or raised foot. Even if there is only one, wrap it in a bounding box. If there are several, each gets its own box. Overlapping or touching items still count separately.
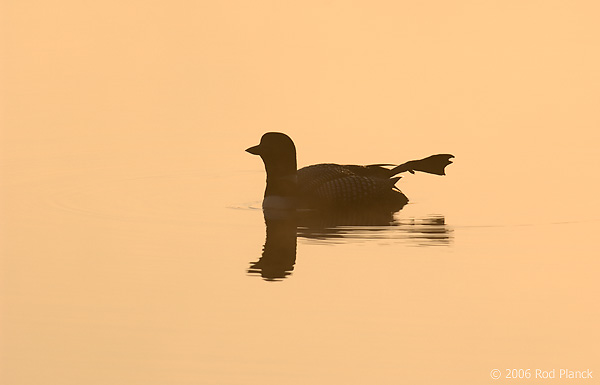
[298,163,407,207]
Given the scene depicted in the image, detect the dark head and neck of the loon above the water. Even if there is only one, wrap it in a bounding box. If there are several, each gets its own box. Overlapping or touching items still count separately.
[246,132,297,207]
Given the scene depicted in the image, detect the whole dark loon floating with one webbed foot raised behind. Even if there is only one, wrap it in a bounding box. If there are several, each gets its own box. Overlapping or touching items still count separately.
[246,132,454,211]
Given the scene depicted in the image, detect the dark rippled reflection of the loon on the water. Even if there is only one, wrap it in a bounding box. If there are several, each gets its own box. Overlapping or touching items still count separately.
[248,209,452,281]
